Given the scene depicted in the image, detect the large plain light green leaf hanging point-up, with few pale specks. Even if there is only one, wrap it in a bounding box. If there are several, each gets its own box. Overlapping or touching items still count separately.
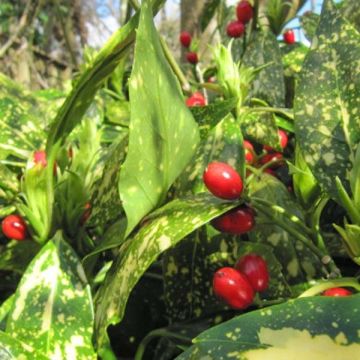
[119,1,199,235]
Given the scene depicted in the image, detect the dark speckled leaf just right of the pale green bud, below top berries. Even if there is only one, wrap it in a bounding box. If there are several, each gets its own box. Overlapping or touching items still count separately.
[242,31,285,106]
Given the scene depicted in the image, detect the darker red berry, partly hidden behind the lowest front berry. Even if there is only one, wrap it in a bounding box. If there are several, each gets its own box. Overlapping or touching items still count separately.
[235,254,269,292]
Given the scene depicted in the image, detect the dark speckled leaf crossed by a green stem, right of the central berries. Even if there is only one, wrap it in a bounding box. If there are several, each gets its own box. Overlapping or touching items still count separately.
[248,174,323,285]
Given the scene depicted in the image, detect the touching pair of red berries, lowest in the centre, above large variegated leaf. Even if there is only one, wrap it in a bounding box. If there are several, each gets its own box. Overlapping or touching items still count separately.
[213,254,270,309]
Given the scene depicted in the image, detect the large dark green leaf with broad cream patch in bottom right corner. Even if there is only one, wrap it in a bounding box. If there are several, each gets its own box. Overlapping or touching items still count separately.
[176,295,360,360]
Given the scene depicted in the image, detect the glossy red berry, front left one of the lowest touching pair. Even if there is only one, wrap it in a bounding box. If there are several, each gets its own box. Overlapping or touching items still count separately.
[213,267,254,309]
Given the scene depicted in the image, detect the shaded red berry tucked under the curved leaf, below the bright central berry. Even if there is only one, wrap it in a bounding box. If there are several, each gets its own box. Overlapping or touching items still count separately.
[211,207,255,235]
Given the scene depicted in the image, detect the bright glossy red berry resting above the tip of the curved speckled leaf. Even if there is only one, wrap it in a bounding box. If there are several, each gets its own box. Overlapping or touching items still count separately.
[203,161,243,200]
